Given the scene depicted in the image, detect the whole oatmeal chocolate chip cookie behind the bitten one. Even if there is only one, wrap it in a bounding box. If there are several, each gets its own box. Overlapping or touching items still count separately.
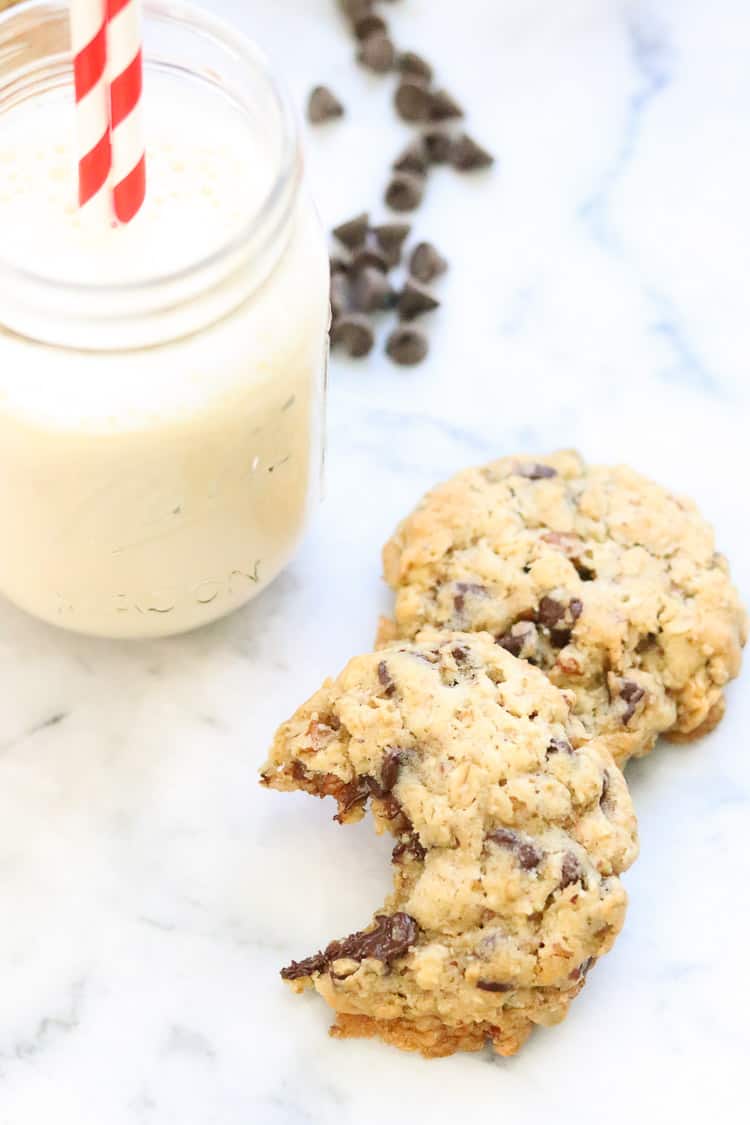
[379,452,747,765]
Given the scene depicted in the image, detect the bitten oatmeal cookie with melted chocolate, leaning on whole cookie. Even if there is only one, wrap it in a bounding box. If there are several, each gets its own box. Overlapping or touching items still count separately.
[262,632,638,1056]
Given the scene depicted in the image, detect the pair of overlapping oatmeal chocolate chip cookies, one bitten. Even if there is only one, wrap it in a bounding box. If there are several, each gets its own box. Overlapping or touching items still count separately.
[263,452,747,1056]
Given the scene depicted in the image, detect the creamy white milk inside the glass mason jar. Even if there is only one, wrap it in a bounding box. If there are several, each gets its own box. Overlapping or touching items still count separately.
[0,86,327,637]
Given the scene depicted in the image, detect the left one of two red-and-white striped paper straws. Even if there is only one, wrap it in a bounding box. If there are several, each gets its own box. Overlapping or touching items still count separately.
[71,0,111,214]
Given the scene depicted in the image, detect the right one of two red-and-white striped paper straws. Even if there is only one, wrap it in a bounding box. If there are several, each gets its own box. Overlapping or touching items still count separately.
[107,0,146,223]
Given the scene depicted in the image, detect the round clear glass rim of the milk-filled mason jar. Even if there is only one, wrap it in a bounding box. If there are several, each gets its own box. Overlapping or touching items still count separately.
[0,0,301,305]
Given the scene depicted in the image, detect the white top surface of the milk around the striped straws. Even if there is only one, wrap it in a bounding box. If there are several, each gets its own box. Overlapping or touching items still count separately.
[0,82,274,285]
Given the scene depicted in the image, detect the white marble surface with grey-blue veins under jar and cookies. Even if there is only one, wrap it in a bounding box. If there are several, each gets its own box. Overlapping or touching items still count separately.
[0,0,750,1125]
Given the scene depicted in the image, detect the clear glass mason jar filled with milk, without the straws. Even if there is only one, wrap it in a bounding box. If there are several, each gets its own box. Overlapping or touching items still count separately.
[0,0,328,637]
